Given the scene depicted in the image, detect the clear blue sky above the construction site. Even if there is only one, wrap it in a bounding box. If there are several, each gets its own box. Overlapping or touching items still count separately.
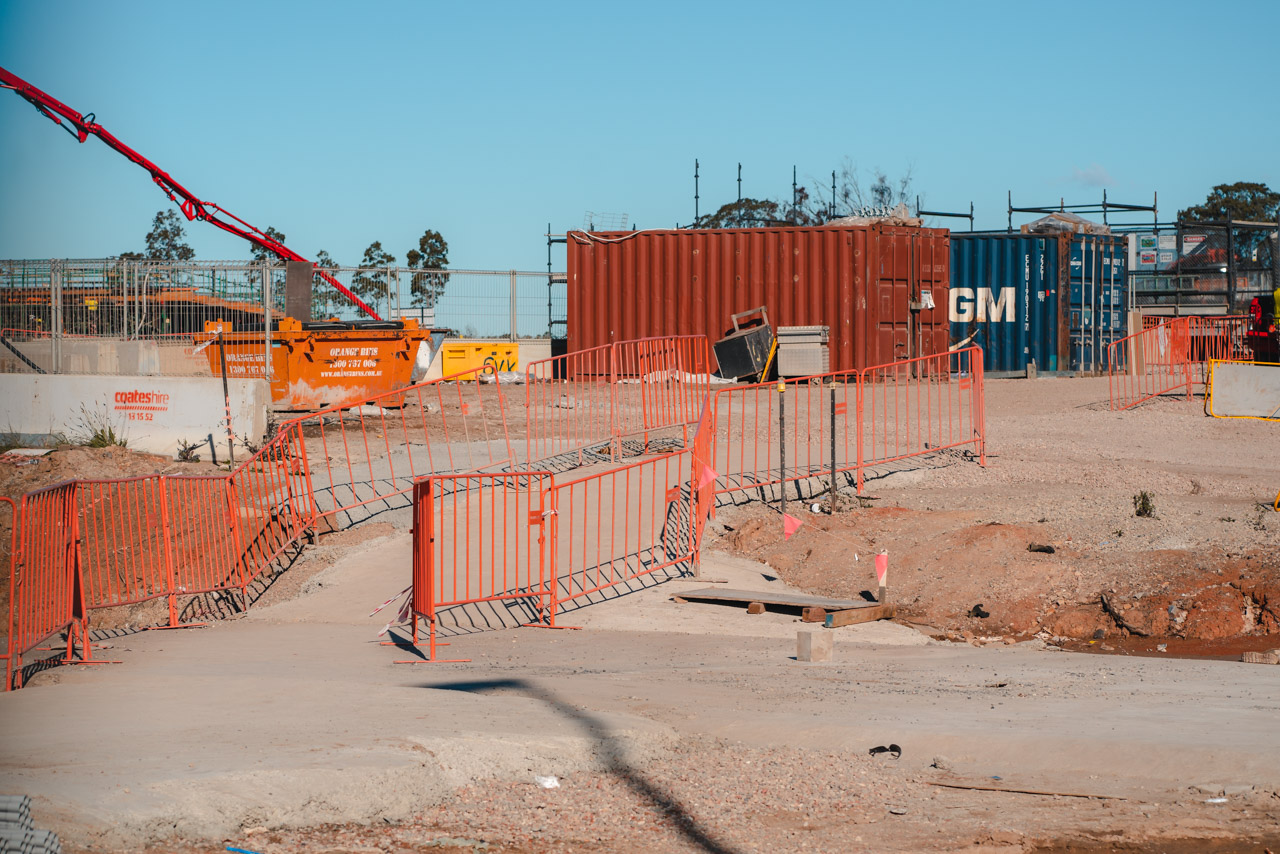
[0,0,1280,270]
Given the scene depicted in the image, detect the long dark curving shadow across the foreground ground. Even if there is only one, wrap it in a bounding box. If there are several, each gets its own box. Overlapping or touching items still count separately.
[419,679,736,854]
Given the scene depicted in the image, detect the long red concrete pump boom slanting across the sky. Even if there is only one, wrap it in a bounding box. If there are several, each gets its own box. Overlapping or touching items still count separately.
[0,68,381,320]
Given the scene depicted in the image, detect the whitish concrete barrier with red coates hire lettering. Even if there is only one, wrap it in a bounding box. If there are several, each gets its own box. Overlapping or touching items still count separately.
[0,374,271,461]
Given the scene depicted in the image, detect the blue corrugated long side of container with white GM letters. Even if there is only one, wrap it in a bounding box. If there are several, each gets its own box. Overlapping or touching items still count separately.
[950,233,1065,371]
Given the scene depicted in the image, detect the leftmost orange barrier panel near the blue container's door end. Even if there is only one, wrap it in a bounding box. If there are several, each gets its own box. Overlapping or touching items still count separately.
[1107,318,1196,410]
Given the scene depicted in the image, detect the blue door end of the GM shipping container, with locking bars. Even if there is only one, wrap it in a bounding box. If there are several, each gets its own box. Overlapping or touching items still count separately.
[1070,234,1129,371]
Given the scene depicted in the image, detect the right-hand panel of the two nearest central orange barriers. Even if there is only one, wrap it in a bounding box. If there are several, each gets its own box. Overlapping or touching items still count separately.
[552,451,694,611]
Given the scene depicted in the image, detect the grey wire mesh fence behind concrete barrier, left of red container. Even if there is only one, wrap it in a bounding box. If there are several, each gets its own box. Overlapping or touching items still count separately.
[0,259,567,376]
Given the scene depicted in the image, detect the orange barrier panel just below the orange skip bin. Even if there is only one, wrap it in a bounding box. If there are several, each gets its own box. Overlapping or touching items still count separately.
[288,365,512,524]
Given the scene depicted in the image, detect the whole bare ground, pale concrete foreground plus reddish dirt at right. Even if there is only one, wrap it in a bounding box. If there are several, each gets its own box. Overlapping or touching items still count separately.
[0,379,1280,854]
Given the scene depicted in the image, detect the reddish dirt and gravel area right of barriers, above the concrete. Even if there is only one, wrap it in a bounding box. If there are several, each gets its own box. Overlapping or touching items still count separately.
[710,379,1280,659]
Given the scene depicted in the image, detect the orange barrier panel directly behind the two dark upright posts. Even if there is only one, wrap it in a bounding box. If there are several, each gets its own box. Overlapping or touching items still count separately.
[712,370,859,494]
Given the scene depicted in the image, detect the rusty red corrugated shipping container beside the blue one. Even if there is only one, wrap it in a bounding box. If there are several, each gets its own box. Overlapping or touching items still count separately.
[567,225,950,371]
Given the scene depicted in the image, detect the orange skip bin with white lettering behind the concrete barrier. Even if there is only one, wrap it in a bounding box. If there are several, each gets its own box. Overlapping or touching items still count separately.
[196,318,433,411]
